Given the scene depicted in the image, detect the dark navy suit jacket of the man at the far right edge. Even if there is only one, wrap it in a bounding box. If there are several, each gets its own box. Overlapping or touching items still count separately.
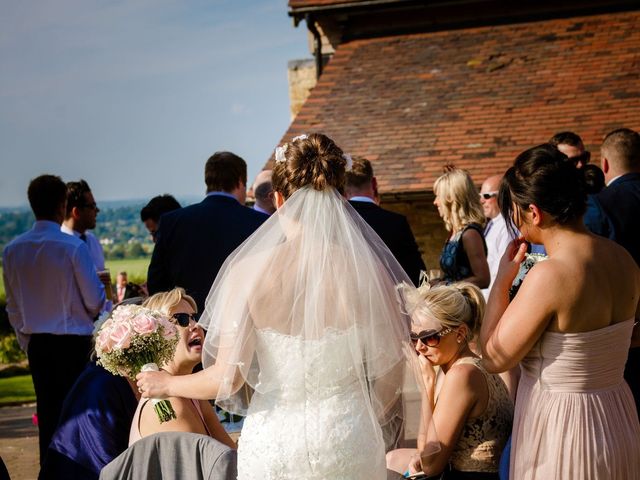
[584,173,640,414]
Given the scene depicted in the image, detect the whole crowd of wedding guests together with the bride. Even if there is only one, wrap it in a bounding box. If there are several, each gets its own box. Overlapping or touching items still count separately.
[3,128,640,480]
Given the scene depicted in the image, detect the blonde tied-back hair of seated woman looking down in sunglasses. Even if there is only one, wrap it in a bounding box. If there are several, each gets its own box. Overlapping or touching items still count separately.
[413,282,485,341]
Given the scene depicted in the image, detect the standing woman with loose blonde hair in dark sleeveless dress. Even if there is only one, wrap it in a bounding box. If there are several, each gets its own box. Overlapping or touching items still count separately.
[433,166,491,288]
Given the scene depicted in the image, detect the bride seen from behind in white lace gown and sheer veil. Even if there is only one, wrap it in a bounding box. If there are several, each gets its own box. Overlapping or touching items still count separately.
[138,134,439,479]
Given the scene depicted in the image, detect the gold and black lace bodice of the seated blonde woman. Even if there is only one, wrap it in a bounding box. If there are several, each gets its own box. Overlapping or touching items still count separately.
[451,357,513,472]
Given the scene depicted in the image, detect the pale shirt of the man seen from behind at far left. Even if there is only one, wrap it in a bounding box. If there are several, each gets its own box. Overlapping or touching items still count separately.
[2,220,105,351]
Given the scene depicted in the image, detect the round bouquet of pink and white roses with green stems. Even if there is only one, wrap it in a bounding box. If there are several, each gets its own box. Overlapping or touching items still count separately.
[95,305,178,423]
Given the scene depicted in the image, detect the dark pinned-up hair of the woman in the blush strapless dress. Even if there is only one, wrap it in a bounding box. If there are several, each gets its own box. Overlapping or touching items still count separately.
[498,143,587,234]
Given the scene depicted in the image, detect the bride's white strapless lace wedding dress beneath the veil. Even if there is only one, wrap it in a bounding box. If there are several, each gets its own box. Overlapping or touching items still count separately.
[238,329,386,480]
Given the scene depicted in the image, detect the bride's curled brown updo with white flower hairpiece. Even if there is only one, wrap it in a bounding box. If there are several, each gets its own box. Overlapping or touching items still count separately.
[271,133,347,199]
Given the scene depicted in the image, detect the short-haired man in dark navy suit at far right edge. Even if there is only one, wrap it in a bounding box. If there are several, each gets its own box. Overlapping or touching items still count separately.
[584,128,640,415]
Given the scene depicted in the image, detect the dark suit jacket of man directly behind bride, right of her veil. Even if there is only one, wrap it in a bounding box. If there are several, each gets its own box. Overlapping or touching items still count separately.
[349,201,426,285]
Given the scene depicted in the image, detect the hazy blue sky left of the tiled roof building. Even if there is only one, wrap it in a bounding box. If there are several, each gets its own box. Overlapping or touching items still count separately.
[0,0,311,207]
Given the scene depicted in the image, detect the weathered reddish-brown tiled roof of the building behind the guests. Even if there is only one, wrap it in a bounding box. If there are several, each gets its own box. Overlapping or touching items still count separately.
[272,11,640,193]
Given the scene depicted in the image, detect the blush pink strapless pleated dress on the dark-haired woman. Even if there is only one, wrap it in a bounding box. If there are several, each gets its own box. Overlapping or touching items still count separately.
[510,319,640,480]
